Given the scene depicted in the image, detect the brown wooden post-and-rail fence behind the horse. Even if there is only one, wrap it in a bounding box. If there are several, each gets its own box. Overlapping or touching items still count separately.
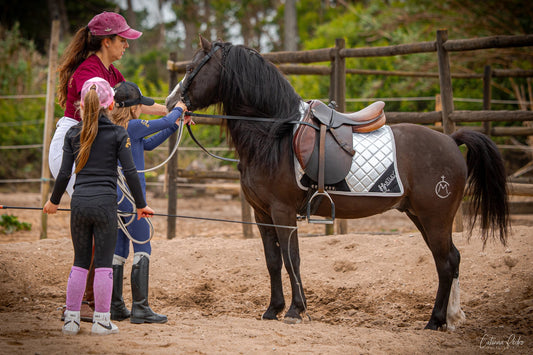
[167,30,533,239]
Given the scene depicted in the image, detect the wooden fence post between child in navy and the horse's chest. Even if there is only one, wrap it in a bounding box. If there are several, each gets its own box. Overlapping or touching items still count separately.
[167,52,178,239]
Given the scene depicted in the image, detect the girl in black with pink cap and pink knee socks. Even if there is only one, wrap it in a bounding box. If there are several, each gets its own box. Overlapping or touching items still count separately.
[43,77,154,335]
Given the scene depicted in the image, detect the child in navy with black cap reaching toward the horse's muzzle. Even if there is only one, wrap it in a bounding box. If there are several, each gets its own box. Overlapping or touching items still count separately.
[111,81,190,323]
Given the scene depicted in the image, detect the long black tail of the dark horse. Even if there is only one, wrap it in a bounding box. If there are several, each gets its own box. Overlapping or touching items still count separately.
[451,129,510,246]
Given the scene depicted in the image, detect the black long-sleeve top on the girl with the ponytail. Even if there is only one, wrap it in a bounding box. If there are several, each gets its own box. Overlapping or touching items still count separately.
[50,115,146,208]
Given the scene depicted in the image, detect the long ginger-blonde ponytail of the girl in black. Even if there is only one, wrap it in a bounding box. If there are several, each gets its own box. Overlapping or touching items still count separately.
[74,85,108,174]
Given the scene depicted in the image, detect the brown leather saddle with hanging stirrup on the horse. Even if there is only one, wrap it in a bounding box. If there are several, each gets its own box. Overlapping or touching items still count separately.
[293,100,386,223]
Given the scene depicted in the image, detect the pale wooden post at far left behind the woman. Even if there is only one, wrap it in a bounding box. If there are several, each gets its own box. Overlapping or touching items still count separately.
[40,19,59,239]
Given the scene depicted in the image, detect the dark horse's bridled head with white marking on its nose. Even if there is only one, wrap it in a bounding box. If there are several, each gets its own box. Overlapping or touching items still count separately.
[165,36,224,111]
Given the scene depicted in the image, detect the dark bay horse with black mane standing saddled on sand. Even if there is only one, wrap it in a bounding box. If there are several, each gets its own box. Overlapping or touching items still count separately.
[166,38,509,330]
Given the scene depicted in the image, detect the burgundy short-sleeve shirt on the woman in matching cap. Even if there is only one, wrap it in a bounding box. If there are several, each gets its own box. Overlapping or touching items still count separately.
[65,54,125,121]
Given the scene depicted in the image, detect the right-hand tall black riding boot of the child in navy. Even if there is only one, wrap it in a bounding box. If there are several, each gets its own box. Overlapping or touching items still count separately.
[130,256,167,324]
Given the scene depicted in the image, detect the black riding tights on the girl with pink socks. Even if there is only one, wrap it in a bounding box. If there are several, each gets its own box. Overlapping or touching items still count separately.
[70,193,117,269]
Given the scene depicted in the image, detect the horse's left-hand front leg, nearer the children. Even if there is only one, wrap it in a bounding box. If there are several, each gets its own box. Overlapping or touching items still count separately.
[255,211,285,320]
